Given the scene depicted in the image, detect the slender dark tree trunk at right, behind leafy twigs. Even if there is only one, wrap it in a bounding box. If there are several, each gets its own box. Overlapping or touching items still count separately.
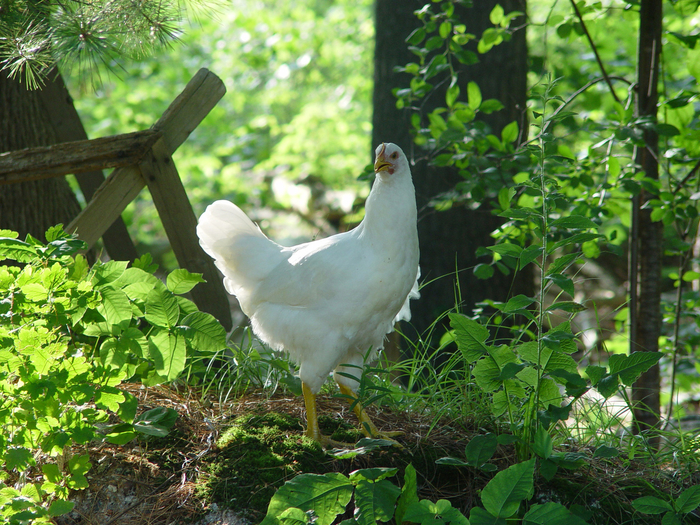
[630,0,663,446]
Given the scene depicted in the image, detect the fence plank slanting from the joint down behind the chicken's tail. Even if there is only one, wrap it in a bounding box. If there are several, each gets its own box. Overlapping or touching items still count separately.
[140,138,232,330]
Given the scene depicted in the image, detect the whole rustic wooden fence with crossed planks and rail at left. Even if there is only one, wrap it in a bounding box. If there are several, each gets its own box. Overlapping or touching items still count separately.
[0,69,232,330]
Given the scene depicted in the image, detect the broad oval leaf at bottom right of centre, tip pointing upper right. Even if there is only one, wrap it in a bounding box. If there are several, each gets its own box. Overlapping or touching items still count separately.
[481,458,535,518]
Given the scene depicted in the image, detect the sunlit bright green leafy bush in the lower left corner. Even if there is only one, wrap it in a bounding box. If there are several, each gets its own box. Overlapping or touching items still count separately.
[0,225,225,524]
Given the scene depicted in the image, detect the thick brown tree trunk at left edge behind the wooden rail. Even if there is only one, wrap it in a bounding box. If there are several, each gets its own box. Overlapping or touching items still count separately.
[0,71,80,241]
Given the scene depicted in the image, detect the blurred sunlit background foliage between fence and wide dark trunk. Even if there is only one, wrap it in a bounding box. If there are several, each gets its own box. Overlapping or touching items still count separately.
[66,0,374,269]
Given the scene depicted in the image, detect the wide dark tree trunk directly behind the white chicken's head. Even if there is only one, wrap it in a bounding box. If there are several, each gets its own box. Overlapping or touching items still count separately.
[372,0,532,344]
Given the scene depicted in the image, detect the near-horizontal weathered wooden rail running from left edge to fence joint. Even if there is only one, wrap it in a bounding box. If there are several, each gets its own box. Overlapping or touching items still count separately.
[0,129,162,184]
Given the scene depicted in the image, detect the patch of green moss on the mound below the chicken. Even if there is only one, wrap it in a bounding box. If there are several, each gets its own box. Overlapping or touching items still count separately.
[199,413,330,517]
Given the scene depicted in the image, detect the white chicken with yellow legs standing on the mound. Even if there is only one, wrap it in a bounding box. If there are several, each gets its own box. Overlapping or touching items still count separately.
[197,144,420,446]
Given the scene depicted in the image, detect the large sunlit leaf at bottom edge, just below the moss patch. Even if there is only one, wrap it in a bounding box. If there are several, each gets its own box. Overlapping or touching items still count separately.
[262,472,353,525]
